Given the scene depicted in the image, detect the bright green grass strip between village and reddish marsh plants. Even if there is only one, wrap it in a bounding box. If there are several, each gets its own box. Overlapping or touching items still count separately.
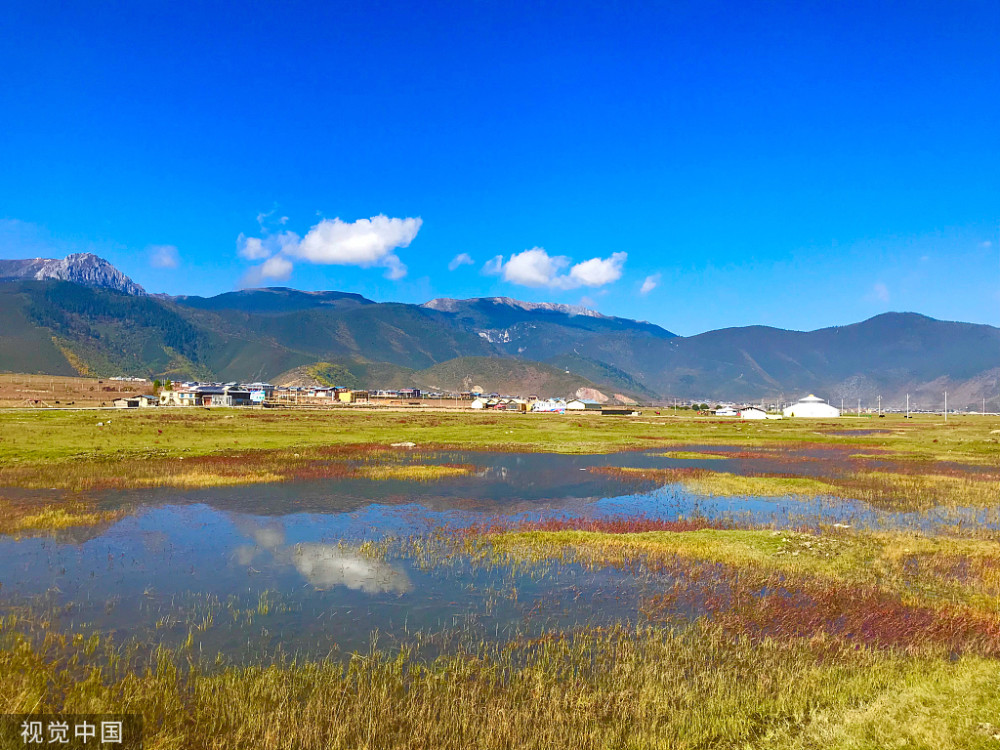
[0,409,1000,464]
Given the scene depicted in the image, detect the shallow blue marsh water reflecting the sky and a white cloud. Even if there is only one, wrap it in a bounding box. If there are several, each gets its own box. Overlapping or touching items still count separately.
[0,451,998,654]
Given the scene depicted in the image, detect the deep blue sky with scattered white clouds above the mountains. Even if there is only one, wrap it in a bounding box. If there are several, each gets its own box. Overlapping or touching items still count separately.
[0,0,1000,334]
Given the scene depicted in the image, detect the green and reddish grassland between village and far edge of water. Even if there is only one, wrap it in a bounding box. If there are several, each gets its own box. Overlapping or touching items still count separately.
[0,408,1000,505]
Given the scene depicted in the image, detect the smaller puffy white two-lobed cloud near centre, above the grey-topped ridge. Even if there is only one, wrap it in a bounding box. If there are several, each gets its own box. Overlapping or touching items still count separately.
[483,247,628,289]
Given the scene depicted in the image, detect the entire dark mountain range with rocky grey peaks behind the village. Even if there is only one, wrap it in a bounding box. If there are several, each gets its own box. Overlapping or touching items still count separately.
[0,254,1000,409]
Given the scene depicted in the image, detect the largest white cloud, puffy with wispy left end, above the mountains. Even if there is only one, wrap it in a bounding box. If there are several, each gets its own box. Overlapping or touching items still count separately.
[236,214,423,283]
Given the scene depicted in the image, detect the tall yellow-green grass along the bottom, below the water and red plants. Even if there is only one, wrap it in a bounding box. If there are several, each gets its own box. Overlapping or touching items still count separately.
[0,622,1000,750]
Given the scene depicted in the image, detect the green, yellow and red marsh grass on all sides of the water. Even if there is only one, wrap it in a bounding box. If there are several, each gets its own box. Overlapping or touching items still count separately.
[0,410,1000,750]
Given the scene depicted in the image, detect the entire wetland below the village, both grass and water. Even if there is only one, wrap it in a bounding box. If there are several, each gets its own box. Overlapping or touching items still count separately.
[0,413,1000,749]
